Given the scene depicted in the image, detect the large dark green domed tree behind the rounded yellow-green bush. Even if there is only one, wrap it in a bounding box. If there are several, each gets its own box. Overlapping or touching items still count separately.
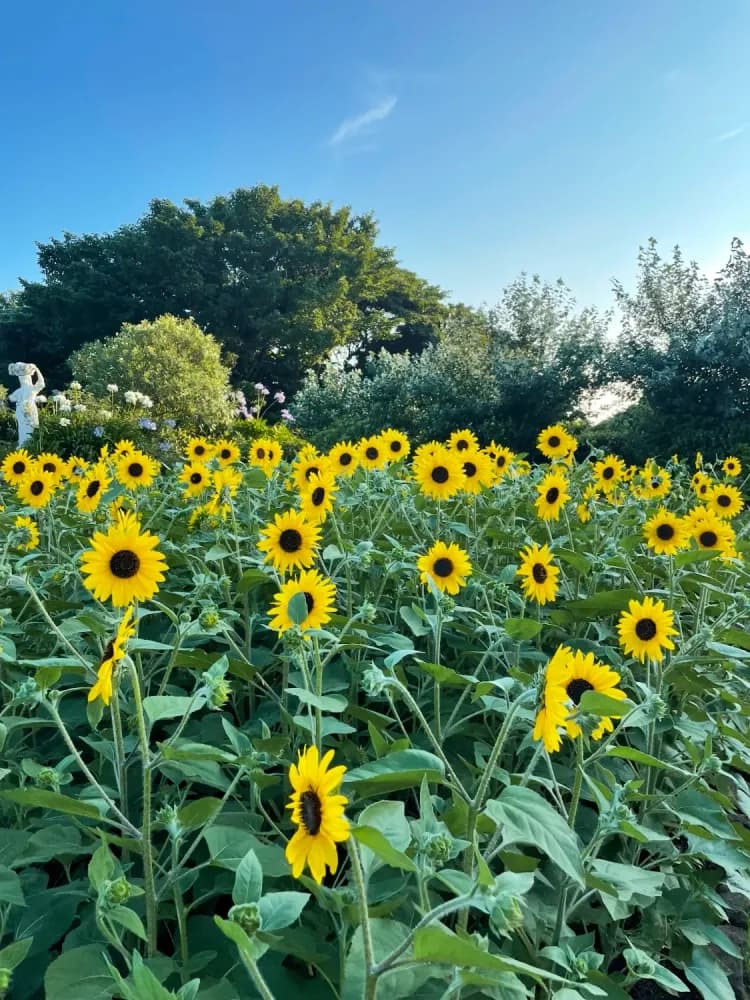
[0,185,443,392]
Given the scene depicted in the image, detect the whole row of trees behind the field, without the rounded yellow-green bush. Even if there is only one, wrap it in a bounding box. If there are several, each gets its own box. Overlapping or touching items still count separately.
[0,185,750,461]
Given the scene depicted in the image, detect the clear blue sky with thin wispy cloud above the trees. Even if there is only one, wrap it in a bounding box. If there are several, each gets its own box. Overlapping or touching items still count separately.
[0,0,750,305]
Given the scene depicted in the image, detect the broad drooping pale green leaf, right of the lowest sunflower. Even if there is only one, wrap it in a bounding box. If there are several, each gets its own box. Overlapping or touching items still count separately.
[485,785,584,886]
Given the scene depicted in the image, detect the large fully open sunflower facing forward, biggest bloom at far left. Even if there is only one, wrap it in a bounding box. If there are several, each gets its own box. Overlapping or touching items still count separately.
[81,514,167,608]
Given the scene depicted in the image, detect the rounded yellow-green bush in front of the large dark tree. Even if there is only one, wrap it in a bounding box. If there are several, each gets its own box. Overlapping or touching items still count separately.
[68,315,234,430]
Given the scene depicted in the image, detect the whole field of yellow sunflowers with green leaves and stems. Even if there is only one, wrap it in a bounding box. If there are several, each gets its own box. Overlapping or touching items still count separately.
[0,425,750,1000]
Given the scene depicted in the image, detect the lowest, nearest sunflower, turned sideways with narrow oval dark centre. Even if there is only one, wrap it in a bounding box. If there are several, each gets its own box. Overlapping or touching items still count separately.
[284,747,349,885]
